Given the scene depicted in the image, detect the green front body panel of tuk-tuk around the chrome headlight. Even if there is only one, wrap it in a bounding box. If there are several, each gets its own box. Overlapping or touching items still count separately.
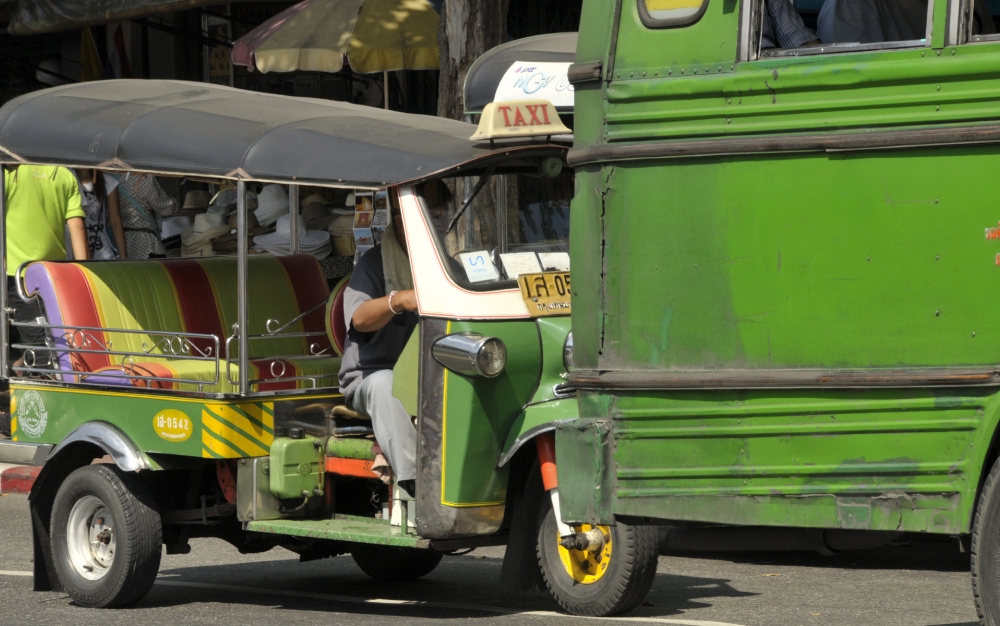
[441,321,544,506]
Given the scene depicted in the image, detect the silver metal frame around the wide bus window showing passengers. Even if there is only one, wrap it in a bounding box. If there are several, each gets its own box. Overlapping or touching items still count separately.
[736,0,936,63]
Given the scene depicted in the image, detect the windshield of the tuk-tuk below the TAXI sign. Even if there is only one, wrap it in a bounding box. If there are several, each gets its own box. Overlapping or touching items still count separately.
[418,158,573,291]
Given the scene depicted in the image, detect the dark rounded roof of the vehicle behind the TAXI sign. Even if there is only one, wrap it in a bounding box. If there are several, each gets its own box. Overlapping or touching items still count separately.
[463,33,577,113]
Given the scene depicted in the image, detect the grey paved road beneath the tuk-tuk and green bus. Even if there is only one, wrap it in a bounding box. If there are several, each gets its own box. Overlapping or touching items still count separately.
[0,496,978,626]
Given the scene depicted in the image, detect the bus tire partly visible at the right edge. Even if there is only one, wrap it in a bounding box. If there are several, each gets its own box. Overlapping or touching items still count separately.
[971,450,1000,626]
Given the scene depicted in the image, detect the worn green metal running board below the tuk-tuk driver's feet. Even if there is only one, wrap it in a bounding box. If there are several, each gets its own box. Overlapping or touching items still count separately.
[247,516,430,548]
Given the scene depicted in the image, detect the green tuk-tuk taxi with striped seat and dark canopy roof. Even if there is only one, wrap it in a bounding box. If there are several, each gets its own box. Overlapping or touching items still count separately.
[0,80,657,615]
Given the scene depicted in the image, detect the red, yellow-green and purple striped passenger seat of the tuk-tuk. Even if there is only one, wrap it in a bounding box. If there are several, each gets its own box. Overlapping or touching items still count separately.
[24,255,340,393]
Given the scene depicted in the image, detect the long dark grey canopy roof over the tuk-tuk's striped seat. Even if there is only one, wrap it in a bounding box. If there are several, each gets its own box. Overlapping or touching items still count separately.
[0,80,510,188]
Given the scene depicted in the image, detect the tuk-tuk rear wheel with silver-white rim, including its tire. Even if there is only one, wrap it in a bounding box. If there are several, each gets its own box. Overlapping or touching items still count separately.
[49,465,162,608]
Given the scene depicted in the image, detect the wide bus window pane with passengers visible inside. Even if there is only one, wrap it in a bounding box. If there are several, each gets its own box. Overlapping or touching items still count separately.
[744,0,936,59]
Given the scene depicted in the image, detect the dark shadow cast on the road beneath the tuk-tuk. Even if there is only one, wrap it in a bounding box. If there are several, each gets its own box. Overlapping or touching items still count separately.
[125,557,757,619]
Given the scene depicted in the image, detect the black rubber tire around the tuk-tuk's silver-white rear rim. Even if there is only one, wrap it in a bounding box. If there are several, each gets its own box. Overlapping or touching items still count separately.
[49,464,163,608]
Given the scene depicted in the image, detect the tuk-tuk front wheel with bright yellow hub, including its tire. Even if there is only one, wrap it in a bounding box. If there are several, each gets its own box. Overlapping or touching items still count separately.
[536,493,658,617]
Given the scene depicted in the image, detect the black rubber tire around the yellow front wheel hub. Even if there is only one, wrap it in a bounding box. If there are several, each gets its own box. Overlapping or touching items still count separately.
[536,493,659,617]
